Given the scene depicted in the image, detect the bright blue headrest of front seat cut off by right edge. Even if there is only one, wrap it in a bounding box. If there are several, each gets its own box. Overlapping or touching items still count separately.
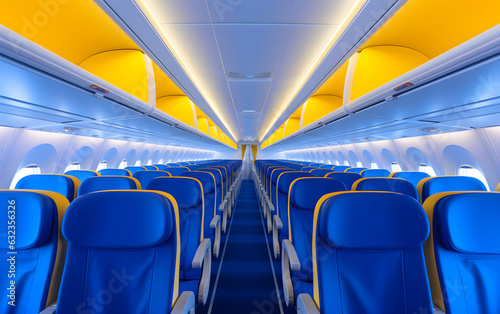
[434,192,500,254]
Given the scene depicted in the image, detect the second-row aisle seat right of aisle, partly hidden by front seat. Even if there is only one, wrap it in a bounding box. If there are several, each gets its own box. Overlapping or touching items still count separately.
[281,178,347,305]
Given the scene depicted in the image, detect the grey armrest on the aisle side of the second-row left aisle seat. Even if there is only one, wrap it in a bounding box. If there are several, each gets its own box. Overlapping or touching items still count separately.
[192,239,212,305]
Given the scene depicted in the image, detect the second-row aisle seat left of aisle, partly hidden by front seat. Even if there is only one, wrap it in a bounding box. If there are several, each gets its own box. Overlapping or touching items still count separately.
[147,177,212,304]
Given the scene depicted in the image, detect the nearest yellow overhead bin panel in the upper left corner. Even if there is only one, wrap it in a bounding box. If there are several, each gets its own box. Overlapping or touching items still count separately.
[0,0,139,65]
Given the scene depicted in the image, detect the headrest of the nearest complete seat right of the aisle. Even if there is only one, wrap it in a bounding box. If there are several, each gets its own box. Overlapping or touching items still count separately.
[317,192,430,250]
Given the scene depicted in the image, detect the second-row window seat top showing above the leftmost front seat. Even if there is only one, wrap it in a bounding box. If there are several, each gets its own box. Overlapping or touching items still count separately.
[16,174,80,202]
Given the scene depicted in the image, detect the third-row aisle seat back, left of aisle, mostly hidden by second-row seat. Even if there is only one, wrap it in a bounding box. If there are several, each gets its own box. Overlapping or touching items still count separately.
[180,171,217,238]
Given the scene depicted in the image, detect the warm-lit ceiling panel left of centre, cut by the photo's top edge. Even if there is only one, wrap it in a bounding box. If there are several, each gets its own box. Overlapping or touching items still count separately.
[145,0,210,23]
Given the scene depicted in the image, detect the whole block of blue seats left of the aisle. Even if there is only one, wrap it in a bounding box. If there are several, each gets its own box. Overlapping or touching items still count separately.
[0,161,242,313]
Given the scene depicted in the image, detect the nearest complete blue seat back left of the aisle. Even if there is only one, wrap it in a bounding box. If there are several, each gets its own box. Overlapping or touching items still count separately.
[56,191,179,313]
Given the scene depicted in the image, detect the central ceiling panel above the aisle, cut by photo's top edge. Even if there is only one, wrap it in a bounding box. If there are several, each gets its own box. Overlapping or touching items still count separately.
[207,0,295,23]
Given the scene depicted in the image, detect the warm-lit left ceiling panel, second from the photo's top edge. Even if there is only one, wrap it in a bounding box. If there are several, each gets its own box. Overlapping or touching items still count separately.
[161,24,224,76]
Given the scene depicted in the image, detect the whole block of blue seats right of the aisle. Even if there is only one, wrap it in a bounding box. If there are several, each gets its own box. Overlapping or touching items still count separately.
[253,161,500,313]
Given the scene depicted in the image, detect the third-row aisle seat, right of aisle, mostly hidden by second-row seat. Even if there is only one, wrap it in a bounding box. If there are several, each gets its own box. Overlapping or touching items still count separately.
[272,171,313,258]
